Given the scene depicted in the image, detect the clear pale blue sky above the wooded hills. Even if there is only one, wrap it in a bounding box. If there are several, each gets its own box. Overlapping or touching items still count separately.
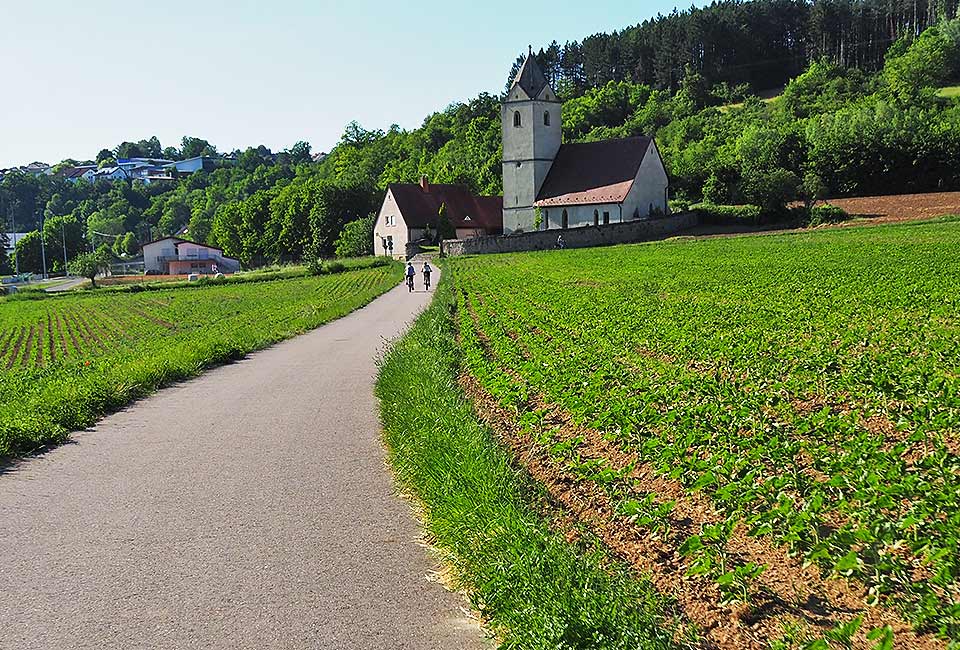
[0,0,703,167]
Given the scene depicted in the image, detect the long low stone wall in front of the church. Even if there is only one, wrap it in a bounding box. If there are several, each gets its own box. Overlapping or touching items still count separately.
[440,212,699,256]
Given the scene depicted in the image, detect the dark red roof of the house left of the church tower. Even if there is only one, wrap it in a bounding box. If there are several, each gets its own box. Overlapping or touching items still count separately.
[387,183,503,233]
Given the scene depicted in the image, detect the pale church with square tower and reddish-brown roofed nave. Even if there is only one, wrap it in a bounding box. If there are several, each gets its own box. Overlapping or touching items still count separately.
[501,51,669,234]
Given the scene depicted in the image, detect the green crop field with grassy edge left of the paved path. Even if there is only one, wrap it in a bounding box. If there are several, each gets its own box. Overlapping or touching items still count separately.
[0,265,399,458]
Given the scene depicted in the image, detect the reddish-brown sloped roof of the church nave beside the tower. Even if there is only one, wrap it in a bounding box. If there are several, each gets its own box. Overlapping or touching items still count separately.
[535,136,652,207]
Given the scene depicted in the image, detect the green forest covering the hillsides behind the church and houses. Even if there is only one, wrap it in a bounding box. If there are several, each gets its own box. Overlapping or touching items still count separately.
[0,0,960,272]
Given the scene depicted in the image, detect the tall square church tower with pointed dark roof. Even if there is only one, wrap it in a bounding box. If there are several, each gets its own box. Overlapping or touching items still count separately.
[500,49,562,234]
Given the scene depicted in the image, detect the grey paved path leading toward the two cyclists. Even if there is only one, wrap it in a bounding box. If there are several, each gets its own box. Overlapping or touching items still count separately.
[0,266,485,650]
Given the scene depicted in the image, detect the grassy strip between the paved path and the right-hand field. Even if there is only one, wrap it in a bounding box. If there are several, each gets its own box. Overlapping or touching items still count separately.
[377,280,677,650]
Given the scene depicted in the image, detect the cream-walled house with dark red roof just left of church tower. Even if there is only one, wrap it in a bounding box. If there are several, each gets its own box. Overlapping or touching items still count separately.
[373,178,503,258]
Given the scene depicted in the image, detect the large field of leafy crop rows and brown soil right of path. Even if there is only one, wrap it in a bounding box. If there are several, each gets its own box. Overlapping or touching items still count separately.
[448,220,960,649]
